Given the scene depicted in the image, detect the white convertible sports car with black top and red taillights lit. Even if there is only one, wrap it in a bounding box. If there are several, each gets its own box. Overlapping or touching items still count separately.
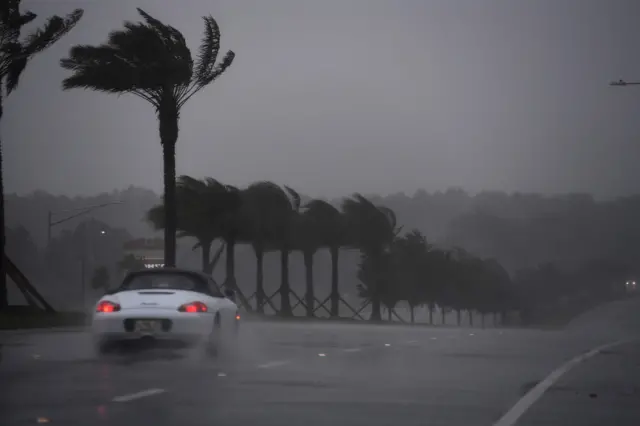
[92,268,240,356]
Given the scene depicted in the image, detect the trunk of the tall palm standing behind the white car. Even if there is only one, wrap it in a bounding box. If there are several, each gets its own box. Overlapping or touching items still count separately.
[158,100,179,267]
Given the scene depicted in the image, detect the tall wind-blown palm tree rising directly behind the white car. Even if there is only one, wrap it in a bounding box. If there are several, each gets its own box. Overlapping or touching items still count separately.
[60,9,235,266]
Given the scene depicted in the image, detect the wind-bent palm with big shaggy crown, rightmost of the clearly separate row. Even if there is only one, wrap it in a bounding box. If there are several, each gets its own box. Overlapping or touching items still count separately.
[342,194,399,321]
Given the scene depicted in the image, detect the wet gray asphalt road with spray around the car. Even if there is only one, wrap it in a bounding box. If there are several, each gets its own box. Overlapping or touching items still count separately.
[0,301,640,426]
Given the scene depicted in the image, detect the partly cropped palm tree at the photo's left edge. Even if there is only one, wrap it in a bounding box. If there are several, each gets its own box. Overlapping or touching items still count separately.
[0,0,83,309]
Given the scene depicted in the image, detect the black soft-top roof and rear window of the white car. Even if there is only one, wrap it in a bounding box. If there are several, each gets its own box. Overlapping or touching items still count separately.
[120,271,216,295]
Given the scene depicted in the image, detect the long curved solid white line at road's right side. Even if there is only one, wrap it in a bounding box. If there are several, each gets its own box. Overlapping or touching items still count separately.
[493,339,637,426]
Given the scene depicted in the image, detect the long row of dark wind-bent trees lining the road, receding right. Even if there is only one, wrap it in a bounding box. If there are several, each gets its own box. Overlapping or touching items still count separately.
[141,176,631,322]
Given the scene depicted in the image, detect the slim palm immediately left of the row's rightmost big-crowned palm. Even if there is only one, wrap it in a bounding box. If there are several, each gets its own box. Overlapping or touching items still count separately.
[304,200,348,317]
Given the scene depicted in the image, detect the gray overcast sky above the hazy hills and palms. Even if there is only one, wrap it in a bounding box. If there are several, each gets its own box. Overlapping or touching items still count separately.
[2,0,640,196]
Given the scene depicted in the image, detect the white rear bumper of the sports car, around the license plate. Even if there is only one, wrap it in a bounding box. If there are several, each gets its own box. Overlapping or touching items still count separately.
[91,309,213,343]
